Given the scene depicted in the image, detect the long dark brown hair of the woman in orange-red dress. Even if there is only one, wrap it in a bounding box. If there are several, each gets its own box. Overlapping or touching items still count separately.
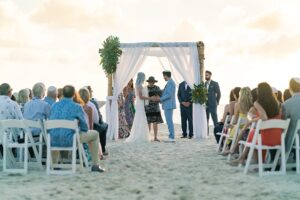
[257,82,279,118]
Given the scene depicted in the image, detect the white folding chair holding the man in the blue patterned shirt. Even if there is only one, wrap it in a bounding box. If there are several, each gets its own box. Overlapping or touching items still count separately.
[44,120,88,175]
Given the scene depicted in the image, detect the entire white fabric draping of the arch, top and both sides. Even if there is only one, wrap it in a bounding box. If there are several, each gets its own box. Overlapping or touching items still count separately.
[106,43,207,140]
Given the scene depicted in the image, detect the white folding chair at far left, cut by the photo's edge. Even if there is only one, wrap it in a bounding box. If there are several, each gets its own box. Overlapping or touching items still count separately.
[0,119,43,174]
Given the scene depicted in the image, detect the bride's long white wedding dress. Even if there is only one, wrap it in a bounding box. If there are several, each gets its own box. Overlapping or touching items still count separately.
[125,87,150,143]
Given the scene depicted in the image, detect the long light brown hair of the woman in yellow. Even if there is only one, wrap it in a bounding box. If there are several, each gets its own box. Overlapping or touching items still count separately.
[238,87,253,114]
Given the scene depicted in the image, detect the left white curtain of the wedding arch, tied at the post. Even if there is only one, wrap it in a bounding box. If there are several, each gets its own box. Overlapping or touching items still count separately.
[106,46,148,140]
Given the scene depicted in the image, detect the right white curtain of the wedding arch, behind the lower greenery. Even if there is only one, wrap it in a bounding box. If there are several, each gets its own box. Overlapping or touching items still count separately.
[161,43,207,139]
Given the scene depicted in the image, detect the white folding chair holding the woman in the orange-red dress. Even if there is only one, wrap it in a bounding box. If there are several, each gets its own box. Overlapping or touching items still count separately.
[244,119,290,177]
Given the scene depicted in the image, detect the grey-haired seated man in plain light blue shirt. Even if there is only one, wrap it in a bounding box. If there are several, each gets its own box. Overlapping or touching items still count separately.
[24,83,50,136]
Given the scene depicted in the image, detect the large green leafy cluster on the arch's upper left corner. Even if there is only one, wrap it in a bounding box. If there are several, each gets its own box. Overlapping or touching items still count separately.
[99,36,122,75]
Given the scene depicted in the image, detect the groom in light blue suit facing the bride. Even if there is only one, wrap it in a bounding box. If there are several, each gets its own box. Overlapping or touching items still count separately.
[157,71,176,142]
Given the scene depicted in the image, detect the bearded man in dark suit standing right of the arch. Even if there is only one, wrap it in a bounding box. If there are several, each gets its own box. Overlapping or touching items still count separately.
[205,71,221,134]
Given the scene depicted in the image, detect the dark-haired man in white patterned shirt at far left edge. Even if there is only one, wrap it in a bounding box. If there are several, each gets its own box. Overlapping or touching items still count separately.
[0,83,23,120]
